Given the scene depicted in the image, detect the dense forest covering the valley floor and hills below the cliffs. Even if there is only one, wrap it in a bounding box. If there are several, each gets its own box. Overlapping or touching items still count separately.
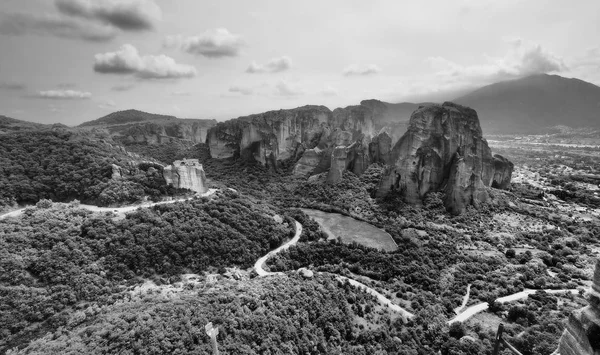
[0,134,600,355]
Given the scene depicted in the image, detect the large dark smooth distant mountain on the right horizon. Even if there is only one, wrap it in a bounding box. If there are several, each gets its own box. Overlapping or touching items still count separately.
[453,74,600,134]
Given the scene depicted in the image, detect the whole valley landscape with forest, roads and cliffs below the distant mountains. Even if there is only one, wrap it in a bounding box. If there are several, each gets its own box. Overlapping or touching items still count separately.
[0,100,600,354]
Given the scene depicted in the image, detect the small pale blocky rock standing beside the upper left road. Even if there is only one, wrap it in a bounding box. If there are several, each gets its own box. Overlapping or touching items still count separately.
[163,159,208,193]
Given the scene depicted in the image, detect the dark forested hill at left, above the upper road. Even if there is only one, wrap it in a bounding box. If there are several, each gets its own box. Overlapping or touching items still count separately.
[0,129,182,210]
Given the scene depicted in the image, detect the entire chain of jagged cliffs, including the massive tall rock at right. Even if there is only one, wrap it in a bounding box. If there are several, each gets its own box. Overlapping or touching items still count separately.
[207,100,513,213]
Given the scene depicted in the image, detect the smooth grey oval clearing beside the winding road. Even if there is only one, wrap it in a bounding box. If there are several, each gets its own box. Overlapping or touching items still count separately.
[302,209,398,251]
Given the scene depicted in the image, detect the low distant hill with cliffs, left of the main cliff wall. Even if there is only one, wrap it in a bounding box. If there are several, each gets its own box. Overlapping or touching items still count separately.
[78,110,217,145]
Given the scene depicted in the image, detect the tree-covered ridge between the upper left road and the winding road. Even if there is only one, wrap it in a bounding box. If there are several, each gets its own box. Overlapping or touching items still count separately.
[0,192,294,349]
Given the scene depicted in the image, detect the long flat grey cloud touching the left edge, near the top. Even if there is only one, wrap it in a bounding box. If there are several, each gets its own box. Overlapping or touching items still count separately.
[0,13,118,42]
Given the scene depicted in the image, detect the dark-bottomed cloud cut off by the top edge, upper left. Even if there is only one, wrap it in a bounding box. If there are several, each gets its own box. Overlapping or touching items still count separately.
[55,0,162,31]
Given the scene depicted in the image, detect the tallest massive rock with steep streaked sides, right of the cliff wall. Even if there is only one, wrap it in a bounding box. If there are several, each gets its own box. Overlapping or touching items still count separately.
[378,102,494,213]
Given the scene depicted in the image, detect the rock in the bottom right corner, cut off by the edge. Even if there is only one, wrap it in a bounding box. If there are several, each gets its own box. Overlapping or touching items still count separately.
[557,259,600,355]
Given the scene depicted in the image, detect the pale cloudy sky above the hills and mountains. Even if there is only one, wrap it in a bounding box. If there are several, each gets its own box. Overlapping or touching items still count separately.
[0,0,600,125]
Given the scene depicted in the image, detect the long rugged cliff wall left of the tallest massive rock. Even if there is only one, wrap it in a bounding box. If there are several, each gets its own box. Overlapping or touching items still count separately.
[207,100,404,175]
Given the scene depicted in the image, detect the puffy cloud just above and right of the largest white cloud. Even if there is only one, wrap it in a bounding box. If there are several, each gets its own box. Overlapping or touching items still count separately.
[164,28,244,58]
